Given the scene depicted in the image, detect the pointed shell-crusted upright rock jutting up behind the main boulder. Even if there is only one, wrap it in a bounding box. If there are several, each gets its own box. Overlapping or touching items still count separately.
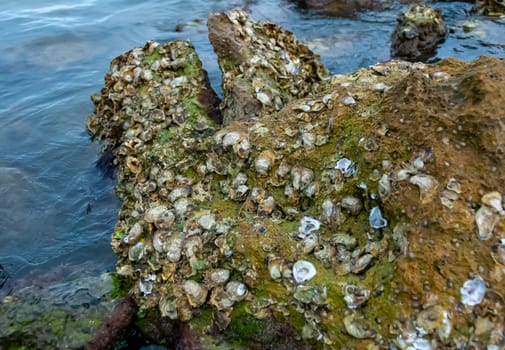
[208,10,329,124]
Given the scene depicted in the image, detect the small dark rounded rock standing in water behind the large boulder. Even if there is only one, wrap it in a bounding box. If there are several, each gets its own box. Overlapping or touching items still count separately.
[391,5,447,61]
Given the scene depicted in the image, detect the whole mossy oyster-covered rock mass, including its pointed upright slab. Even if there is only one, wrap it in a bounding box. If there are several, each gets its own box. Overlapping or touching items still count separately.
[88,11,505,349]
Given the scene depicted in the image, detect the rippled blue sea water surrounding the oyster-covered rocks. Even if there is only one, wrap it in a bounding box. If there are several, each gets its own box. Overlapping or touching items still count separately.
[0,0,505,293]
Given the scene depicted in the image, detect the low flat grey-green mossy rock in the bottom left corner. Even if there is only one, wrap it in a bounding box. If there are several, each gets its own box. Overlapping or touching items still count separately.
[0,274,123,349]
